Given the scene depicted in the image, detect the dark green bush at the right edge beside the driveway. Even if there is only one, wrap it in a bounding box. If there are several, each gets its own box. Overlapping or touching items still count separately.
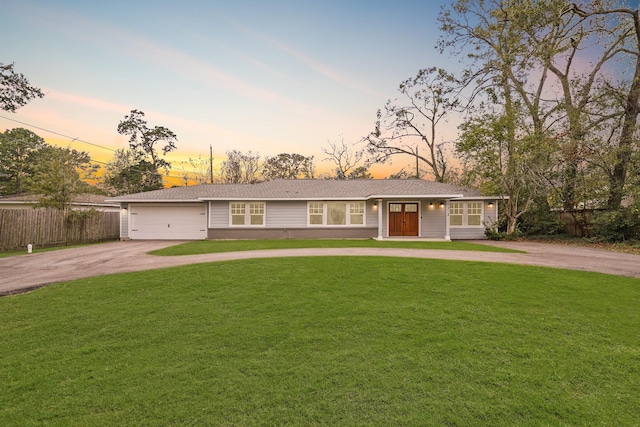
[593,205,640,242]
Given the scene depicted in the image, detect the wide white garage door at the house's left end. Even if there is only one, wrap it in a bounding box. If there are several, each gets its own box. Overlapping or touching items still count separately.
[129,203,207,240]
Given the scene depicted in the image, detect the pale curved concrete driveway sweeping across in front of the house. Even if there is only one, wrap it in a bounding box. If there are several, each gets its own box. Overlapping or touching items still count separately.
[0,241,640,295]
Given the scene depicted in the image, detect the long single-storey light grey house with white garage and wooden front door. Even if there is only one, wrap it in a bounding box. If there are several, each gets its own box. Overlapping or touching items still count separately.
[110,179,498,240]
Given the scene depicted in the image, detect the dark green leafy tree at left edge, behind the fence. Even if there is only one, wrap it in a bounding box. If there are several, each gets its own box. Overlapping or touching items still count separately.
[0,128,46,195]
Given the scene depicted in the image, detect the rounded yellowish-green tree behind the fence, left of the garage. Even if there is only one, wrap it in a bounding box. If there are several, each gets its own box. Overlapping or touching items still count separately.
[29,146,98,211]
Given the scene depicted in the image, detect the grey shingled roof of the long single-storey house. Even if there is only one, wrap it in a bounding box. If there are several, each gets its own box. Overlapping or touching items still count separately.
[110,179,480,202]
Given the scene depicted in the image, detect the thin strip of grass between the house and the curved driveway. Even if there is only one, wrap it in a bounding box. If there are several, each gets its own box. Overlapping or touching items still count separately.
[151,239,521,256]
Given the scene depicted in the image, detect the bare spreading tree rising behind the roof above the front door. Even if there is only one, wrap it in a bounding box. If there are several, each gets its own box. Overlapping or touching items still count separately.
[365,67,460,182]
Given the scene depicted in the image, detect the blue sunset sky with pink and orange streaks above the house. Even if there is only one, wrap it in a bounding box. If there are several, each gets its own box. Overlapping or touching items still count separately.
[0,0,456,182]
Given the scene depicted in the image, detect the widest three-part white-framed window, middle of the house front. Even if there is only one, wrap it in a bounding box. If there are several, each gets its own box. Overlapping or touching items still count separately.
[307,201,365,227]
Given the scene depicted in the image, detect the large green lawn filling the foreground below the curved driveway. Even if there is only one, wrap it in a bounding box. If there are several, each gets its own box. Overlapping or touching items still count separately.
[0,257,640,426]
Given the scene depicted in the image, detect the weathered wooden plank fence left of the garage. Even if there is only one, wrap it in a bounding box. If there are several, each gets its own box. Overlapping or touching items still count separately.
[0,209,120,251]
